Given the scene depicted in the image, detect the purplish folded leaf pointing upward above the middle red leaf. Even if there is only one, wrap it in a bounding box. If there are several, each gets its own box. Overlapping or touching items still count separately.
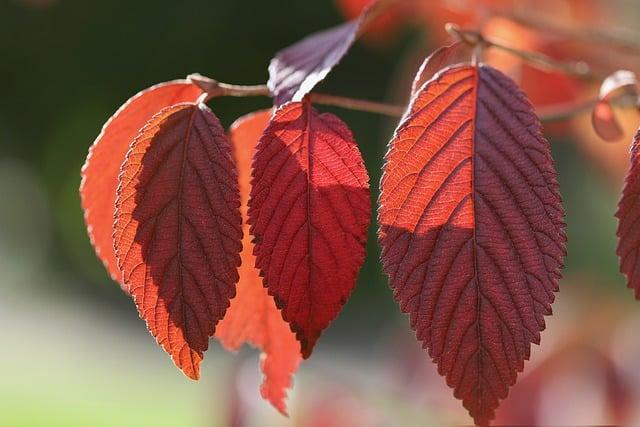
[267,7,371,106]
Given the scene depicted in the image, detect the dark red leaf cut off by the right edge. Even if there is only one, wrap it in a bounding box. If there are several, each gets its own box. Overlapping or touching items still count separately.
[616,130,640,299]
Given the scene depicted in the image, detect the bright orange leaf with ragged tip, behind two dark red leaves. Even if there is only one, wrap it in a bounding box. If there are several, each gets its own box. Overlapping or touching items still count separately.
[216,110,301,415]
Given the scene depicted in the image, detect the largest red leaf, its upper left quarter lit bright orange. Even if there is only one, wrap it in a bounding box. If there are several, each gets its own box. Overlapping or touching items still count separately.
[378,65,566,425]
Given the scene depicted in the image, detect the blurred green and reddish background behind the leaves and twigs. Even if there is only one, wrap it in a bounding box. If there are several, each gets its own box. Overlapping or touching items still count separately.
[0,0,640,427]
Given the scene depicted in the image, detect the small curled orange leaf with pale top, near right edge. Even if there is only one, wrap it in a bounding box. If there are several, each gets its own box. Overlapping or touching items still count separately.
[591,70,640,142]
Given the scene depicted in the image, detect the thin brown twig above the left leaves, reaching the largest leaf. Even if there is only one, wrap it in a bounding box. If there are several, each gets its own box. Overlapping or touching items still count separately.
[187,74,405,117]
